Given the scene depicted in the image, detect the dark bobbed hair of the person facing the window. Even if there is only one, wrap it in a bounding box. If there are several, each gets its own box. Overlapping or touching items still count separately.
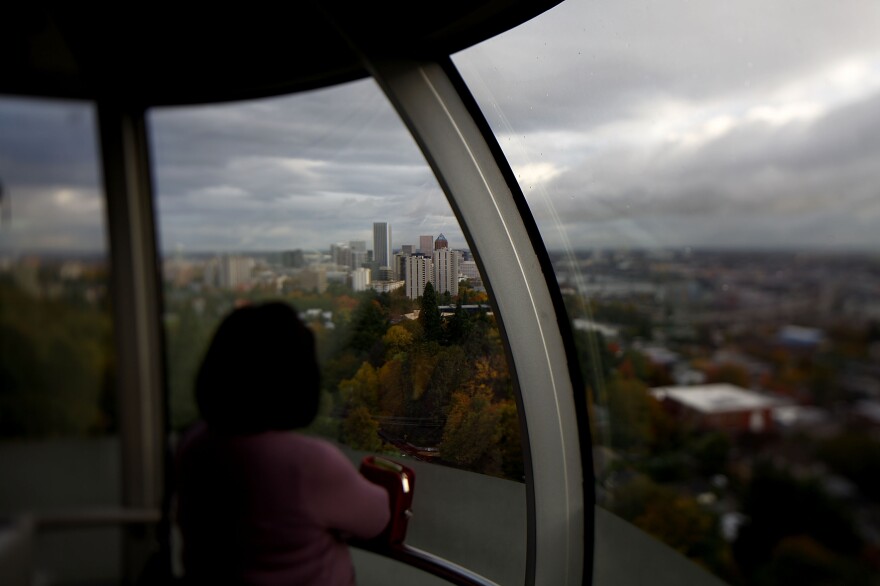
[196,301,321,434]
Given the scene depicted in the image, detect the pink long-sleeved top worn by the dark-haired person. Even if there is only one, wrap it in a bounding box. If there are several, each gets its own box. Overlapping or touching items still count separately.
[177,424,390,586]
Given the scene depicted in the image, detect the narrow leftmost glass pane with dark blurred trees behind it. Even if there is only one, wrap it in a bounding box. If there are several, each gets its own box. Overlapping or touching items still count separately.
[0,97,120,582]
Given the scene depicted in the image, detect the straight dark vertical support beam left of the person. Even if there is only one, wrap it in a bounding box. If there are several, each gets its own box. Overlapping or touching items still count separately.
[98,102,165,581]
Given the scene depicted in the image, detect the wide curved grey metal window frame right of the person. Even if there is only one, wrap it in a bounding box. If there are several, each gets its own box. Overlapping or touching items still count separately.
[367,58,594,586]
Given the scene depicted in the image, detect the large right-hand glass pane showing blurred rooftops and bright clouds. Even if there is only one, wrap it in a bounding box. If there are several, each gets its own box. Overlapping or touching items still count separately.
[454,0,880,584]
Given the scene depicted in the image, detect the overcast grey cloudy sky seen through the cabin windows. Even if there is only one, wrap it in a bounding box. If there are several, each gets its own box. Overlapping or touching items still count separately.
[0,0,880,252]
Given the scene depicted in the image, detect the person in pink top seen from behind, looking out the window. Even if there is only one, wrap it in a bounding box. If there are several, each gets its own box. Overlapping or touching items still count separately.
[177,302,390,586]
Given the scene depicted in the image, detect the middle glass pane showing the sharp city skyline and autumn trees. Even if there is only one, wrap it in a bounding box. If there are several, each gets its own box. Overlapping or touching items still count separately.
[150,80,525,582]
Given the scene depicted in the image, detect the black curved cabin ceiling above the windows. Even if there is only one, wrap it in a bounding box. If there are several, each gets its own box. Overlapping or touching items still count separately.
[0,0,559,107]
